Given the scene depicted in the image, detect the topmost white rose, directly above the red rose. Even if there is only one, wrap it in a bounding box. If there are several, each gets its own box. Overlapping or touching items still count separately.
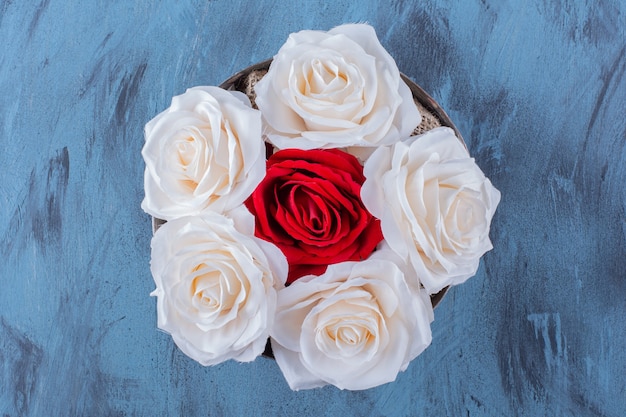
[255,24,421,149]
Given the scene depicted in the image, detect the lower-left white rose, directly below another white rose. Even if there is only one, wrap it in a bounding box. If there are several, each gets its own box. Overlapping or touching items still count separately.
[150,207,287,365]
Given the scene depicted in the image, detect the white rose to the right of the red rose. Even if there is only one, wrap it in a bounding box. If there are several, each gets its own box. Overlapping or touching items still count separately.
[361,128,500,294]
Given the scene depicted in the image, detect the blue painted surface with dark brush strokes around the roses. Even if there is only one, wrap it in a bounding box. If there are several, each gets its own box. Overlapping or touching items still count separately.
[0,0,626,417]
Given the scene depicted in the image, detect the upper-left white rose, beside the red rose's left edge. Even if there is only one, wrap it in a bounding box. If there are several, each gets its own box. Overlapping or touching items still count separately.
[141,87,265,220]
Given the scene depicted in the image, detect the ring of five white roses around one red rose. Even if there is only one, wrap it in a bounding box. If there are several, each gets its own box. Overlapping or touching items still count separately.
[142,24,500,390]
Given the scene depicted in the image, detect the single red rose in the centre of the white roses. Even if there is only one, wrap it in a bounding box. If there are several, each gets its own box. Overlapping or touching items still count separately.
[246,149,383,283]
